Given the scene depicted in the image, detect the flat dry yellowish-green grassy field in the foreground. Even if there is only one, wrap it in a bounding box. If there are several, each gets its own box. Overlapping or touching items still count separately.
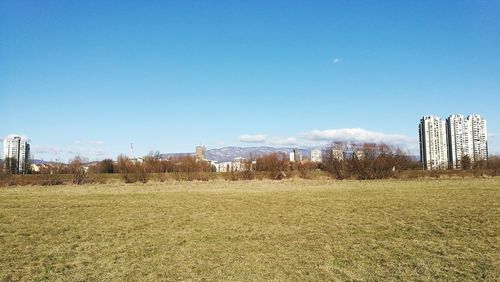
[0,178,500,281]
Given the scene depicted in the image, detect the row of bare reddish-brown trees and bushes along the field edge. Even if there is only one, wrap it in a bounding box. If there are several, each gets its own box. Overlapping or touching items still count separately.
[0,142,500,184]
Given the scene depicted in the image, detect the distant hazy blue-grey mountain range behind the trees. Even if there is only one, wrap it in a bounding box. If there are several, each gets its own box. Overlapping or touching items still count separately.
[161,146,310,162]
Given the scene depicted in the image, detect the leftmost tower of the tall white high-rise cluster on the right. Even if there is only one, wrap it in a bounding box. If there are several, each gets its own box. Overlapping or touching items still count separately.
[419,115,448,170]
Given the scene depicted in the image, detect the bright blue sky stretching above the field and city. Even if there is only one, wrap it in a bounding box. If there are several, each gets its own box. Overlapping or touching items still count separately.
[0,0,500,161]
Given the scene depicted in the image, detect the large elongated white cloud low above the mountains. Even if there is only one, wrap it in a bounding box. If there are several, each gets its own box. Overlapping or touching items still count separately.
[301,128,415,145]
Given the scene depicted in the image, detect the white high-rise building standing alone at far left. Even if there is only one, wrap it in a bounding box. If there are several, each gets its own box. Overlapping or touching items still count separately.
[3,135,30,174]
